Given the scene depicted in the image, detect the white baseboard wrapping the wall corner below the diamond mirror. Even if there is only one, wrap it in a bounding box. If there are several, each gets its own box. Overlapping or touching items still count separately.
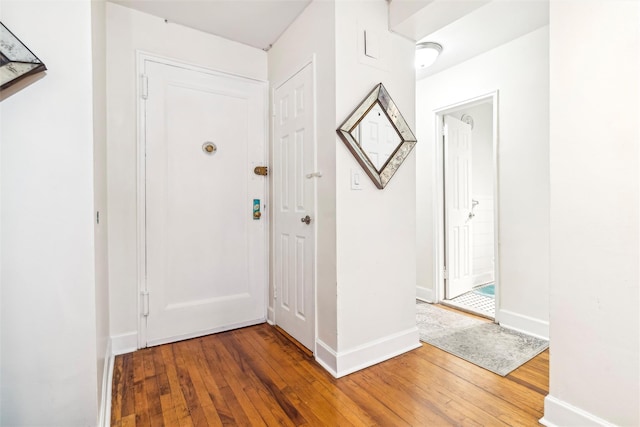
[316,327,421,378]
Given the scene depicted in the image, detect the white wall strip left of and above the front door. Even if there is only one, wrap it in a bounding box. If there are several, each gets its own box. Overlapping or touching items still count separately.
[107,3,267,351]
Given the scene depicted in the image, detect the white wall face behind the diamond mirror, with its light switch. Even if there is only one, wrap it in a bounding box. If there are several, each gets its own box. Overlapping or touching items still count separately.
[333,0,418,373]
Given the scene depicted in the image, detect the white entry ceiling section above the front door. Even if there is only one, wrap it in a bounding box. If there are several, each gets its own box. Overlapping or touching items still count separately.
[109,0,311,50]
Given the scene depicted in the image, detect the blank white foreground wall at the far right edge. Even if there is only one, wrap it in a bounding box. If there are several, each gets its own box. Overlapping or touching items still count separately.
[543,1,640,426]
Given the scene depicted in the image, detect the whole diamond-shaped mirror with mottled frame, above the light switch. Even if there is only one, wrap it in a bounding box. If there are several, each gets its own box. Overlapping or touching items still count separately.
[337,83,417,189]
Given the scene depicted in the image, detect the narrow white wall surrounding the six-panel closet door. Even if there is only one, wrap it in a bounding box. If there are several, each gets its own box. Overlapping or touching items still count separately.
[268,1,337,349]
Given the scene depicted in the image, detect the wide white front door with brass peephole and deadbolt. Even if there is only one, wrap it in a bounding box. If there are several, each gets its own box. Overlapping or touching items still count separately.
[141,60,267,345]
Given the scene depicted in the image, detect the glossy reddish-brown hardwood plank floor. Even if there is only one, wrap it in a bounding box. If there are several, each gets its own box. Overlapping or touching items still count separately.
[111,324,549,427]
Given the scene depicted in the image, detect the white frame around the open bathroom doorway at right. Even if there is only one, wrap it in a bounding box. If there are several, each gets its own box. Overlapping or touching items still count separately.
[433,90,500,323]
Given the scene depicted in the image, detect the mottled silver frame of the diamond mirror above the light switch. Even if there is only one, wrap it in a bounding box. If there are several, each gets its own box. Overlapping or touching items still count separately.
[336,83,418,189]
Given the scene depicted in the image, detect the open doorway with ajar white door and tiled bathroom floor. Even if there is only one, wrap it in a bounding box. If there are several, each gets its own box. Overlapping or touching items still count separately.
[437,94,498,319]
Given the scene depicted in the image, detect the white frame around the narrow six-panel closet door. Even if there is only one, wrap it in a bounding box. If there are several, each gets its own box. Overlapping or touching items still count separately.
[267,53,321,354]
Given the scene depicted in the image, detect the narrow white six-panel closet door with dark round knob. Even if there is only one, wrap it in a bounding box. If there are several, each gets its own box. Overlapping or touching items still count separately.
[273,64,319,351]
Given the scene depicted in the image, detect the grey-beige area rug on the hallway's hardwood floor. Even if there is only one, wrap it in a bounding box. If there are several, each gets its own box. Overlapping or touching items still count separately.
[416,302,549,377]
